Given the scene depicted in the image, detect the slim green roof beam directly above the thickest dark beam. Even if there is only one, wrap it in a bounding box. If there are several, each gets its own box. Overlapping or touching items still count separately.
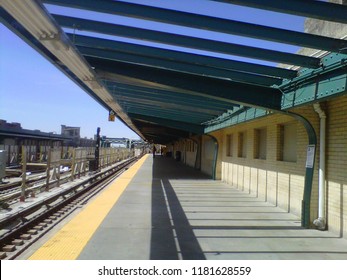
[78,47,282,86]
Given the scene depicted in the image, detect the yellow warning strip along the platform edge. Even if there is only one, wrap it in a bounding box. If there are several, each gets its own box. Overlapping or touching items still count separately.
[29,155,148,260]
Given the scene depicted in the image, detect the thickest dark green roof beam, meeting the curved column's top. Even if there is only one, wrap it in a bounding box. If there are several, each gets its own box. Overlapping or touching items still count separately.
[88,58,282,110]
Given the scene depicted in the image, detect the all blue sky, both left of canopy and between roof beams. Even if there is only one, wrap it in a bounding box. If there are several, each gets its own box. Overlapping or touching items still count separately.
[0,0,304,138]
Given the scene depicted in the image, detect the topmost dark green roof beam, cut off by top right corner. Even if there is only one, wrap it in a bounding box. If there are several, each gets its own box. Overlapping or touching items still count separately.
[212,0,347,23]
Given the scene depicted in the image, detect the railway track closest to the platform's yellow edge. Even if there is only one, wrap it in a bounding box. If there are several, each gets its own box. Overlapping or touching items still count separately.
[0,157,138,260]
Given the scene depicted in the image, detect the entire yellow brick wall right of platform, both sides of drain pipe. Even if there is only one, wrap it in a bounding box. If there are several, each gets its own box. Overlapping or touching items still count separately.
[207,96,347,237]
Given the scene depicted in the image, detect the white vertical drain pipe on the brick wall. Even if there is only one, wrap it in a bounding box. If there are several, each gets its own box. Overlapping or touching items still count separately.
[313,103,326,230]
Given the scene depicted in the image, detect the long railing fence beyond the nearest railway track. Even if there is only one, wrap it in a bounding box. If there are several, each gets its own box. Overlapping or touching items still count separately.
[0,146,138,207]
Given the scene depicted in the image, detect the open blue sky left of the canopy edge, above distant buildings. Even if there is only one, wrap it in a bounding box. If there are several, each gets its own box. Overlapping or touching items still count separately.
[0,25,138,138]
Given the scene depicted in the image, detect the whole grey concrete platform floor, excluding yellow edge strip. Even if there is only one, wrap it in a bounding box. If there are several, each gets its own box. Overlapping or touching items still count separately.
[30,156,347,260]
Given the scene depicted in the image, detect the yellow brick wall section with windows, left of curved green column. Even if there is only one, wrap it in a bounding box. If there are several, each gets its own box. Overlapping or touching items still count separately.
[211,108,317,216]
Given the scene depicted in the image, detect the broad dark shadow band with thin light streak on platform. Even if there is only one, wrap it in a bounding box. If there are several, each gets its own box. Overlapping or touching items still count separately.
[150,157,206,260]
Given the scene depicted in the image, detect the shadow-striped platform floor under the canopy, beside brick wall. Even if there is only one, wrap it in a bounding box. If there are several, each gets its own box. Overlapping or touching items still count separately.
[150,156,347,260]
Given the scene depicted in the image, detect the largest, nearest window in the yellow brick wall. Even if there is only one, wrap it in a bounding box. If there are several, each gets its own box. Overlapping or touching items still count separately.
[277,124,297,162]
